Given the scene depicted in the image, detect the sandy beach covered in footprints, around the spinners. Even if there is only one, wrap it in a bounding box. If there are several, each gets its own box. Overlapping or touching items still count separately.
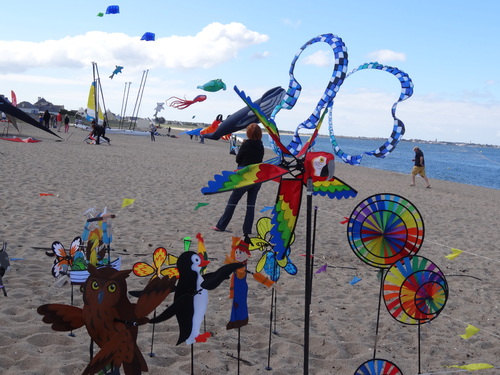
[0,126,500,375]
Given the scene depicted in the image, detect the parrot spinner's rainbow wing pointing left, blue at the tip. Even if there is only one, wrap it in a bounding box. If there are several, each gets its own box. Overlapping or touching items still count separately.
[201,163,288,195]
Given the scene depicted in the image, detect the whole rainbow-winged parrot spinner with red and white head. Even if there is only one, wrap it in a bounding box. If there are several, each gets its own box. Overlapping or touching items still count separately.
[201,101,357,281]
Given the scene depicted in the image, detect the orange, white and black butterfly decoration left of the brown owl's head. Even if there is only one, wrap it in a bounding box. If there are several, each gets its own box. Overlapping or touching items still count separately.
[47,237,87,278]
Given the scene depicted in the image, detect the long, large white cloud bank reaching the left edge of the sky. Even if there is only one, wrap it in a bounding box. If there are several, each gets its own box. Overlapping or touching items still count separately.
[0,22,269,74]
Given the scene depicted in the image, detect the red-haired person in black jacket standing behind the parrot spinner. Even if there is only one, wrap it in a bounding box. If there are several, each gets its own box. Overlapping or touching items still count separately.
[211,123,264,238]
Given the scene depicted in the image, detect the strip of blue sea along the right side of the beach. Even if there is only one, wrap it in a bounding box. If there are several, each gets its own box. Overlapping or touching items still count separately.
[250,134,500,189]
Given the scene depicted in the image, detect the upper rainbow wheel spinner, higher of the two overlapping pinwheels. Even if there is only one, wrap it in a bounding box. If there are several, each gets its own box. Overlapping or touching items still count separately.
[347,194,424,268]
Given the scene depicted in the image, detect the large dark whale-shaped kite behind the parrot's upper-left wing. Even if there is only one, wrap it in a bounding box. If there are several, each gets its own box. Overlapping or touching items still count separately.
[201,87,285,140]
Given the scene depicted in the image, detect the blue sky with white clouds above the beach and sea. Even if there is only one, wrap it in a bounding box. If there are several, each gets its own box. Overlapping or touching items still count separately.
[0,0,500,145]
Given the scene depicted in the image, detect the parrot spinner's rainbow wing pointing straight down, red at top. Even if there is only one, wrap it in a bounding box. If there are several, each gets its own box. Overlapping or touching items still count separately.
[270,178,303,261]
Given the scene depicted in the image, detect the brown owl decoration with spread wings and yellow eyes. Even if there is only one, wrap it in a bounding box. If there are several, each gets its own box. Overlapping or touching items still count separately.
[37,265,176,375]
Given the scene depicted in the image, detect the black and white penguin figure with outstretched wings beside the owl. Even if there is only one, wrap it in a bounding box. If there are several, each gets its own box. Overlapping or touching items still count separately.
[149,251,244,345]
